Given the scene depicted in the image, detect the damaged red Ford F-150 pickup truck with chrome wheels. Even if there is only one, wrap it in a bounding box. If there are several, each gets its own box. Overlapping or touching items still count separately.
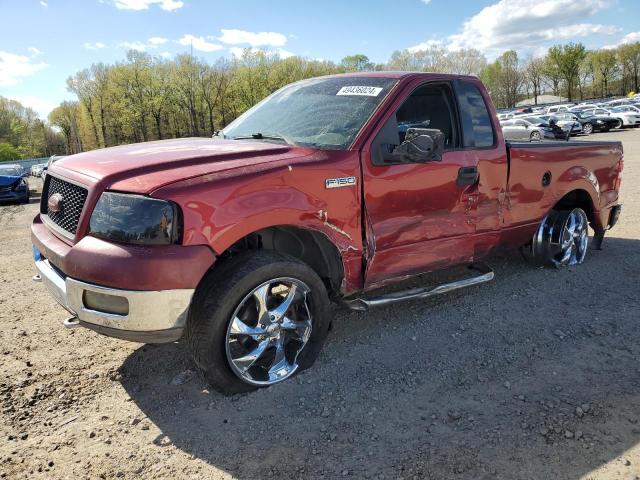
[31,72,623,393]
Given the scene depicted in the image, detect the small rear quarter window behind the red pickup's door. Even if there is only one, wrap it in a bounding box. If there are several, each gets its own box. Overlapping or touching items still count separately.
[456,81,495,148]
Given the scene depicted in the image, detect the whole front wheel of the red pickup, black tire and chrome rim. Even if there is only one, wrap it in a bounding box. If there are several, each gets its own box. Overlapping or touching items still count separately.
[185,250,329,394]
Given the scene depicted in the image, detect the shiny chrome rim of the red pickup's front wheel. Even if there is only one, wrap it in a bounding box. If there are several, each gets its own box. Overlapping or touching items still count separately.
[225,277,312,385]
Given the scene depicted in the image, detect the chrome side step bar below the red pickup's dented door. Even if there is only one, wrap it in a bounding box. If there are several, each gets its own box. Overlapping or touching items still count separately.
[342,264,493,312]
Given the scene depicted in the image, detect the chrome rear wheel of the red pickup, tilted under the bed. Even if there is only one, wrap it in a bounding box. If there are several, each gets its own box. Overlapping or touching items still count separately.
[531,208,589,268]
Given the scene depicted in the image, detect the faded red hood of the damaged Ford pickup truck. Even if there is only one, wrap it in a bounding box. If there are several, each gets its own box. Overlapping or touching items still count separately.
[50,138,315,193]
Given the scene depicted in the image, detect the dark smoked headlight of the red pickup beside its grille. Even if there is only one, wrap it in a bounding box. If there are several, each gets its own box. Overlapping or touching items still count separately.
[89,192,181,245]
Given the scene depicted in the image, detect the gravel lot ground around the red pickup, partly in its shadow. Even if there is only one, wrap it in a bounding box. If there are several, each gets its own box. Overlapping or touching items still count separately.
[0,130,640,479]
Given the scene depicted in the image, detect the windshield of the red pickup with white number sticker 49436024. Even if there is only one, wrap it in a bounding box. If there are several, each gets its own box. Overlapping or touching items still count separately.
[221,76,396,150]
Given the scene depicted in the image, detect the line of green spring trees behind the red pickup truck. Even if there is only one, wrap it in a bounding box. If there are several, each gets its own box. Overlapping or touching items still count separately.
[0,43,640,157]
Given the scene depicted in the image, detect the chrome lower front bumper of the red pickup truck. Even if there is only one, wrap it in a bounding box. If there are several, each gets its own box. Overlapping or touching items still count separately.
[35,257,194,343]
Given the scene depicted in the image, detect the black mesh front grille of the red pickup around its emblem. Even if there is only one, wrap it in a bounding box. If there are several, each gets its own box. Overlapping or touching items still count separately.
[40,175,87,235]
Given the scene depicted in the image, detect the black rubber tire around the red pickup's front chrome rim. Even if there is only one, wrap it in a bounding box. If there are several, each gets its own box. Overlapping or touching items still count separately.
[185,250,330,395]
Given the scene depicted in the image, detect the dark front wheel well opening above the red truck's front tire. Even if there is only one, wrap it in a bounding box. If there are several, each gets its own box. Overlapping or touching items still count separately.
[220,226,344,296]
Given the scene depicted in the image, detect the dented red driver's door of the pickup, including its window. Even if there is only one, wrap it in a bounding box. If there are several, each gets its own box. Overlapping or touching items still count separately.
[362,82,477,288]
